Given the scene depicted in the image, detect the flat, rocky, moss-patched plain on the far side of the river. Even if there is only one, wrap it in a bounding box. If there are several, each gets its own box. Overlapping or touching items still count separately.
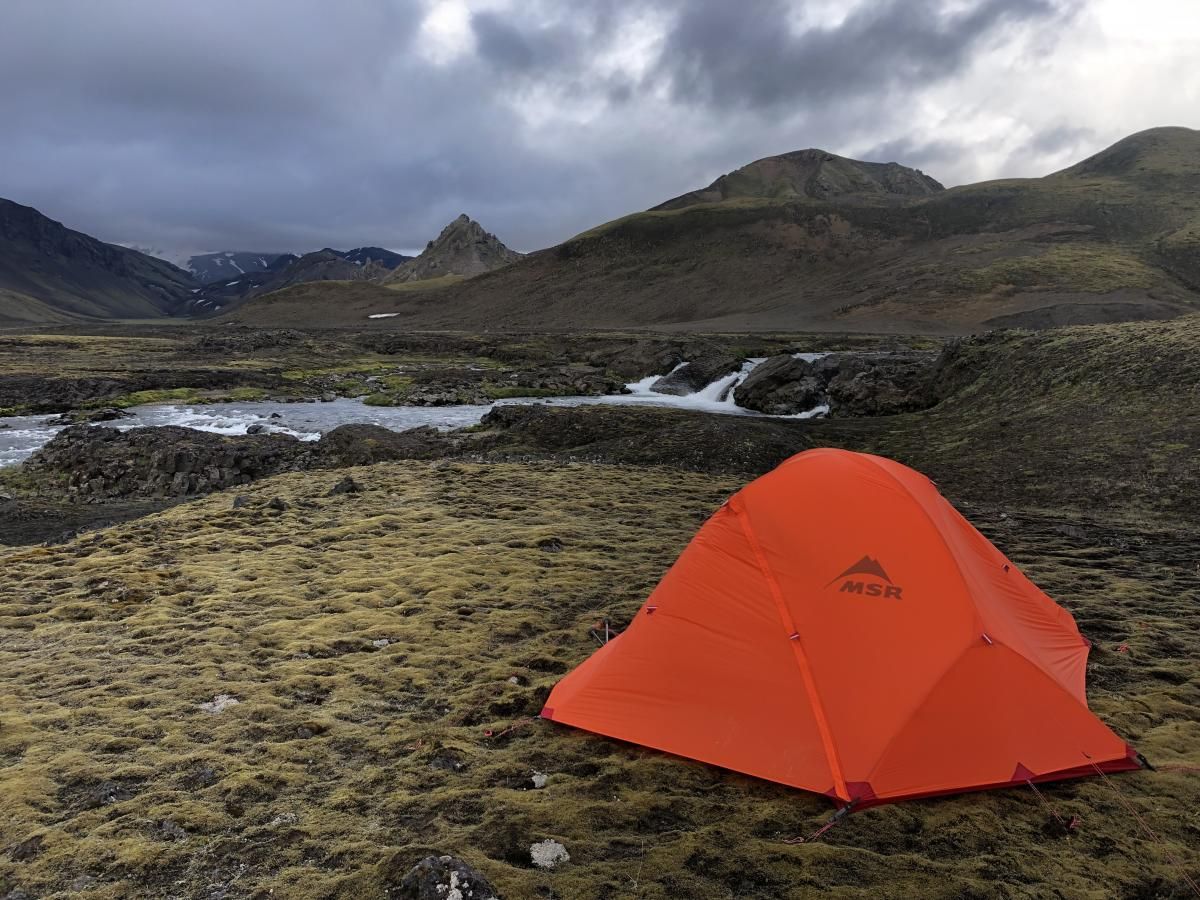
[0,325,926,415]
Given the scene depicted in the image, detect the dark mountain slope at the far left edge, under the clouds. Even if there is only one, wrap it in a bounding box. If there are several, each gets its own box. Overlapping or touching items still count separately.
[0,199,196,322]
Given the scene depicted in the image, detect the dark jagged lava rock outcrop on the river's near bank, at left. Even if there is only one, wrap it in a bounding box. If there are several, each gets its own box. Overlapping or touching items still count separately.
[25,425,301,500]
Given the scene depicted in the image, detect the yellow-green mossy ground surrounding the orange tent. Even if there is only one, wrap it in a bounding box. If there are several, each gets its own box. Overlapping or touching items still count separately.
[0,462,1200,900]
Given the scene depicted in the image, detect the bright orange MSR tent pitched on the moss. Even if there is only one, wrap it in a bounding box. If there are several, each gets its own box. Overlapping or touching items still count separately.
[541,449,1139,808]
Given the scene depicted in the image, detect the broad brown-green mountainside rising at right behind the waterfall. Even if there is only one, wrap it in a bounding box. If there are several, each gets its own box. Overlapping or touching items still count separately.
[251,127,1200,334]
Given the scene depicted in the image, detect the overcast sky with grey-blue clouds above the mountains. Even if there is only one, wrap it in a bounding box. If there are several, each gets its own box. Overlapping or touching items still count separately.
[0,0,1200,252]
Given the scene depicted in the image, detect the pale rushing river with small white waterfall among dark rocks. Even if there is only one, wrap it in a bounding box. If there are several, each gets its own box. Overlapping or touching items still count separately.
[0,357,829,468]
